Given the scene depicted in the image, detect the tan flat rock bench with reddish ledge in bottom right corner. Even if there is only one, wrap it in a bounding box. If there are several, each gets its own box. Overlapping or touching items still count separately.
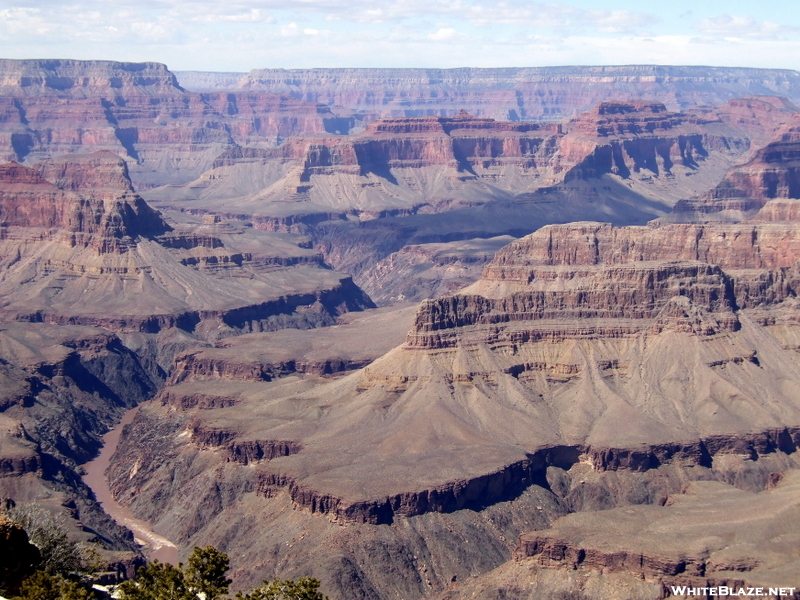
[515,471,800,598]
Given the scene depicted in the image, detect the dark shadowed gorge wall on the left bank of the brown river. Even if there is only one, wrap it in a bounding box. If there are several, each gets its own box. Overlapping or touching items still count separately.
[0,323,158,551]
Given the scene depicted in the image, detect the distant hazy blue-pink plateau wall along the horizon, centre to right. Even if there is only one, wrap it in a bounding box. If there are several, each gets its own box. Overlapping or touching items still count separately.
[230,65,800,121]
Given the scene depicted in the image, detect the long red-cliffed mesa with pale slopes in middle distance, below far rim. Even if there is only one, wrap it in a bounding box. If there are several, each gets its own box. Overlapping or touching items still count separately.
[158,101,764,219]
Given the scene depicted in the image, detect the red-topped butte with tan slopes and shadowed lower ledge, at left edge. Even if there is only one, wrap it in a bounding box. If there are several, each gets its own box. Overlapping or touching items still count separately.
[0,153,371,333]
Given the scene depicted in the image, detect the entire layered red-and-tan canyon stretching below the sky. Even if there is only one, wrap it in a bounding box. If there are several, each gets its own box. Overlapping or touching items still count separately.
[0,60,800,600]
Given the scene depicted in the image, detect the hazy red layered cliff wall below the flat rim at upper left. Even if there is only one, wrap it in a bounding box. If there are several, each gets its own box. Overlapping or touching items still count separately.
[0,60,344,187]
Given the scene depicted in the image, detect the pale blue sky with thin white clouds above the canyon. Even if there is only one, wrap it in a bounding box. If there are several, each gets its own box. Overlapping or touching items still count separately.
[0,0,800,72]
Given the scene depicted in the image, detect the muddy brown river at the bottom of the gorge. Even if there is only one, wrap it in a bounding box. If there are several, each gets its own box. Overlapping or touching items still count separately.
[83,407,178,565]
